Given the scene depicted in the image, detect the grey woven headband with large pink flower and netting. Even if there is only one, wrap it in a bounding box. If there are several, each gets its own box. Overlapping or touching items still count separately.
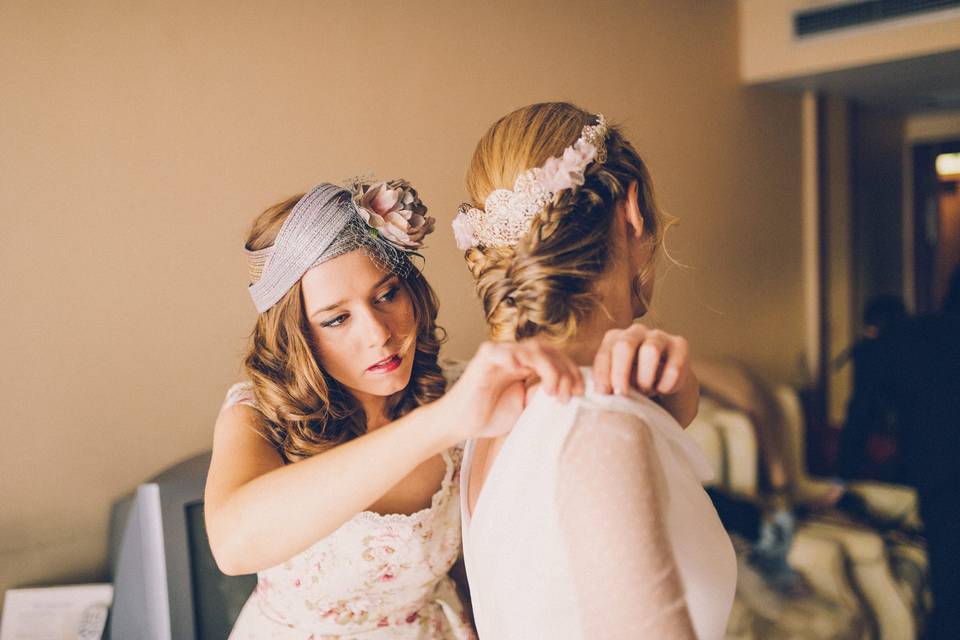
[245,179,434,313]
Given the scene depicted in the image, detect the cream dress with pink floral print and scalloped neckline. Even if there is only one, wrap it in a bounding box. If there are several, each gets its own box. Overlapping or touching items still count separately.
[217,383,476,640]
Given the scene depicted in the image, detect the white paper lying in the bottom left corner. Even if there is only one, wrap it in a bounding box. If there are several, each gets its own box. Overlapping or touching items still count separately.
[0,584,113,640]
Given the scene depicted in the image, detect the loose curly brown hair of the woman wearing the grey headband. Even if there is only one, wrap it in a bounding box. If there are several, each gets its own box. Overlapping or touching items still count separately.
[243,193,446,463]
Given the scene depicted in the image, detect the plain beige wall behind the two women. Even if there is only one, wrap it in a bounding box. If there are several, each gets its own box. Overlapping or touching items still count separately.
[0,0,803,600]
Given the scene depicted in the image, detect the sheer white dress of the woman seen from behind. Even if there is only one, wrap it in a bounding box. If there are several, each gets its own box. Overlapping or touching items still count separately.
[461,369,737,640]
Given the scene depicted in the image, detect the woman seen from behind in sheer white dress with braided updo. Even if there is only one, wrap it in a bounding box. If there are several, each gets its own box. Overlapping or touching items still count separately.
[454,103,736,640]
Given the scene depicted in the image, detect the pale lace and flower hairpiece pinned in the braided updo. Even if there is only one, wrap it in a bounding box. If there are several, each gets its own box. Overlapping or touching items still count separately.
[453,113,607,251]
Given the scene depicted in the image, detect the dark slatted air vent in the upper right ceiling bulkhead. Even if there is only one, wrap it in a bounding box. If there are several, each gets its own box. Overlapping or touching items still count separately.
[793,0,960,38]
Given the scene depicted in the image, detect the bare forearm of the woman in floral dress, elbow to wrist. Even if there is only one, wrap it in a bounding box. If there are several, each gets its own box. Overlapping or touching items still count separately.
[206,401,456,574]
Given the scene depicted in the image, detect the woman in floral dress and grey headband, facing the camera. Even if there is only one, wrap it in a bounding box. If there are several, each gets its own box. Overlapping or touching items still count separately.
[205,180,688,640]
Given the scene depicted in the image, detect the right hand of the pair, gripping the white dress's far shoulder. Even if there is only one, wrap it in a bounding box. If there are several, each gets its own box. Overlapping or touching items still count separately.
[593,323,700,427]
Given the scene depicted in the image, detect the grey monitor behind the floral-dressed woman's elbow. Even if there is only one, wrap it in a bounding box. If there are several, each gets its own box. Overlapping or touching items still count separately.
[107,452,257,640]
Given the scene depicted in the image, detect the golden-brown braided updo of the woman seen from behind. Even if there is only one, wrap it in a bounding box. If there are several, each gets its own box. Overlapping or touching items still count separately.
[465,102,668,341]
